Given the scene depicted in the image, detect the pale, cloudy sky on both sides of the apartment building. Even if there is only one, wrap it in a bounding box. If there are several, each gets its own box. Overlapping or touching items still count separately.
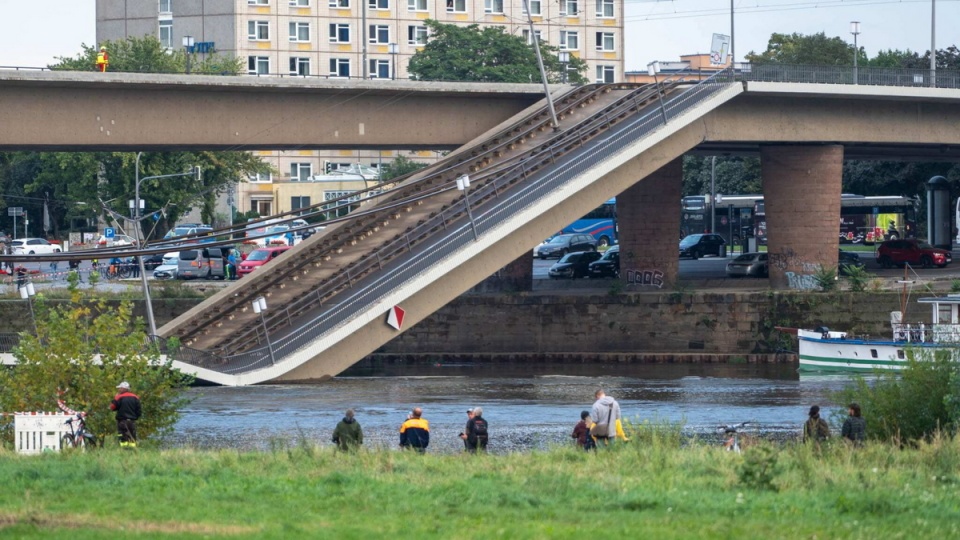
[0,0,960,71]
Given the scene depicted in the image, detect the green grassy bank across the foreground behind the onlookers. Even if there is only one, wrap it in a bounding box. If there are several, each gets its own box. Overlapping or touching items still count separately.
[0,439,960,538]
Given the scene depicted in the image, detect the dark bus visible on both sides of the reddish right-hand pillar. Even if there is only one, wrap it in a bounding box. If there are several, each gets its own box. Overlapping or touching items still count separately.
[680,194,919,246]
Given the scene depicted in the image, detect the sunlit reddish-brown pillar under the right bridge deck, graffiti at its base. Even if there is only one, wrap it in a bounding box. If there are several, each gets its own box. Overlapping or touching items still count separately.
[760,145,843,289]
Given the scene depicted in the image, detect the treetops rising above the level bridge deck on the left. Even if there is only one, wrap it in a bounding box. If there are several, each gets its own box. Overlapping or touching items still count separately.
[49,36,243,75]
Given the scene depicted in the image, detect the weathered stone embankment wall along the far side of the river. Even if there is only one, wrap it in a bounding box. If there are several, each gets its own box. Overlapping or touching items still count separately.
[0,291,916,362]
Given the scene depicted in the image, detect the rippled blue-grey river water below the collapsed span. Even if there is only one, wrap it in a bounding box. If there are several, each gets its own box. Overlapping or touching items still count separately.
[164,364,849,453]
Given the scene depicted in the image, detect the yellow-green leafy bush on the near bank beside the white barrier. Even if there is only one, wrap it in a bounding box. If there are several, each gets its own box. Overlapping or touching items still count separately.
[0,277,192,446]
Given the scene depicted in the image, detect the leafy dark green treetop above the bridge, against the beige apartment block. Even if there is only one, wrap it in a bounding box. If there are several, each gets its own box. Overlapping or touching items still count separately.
[407,20,587,83]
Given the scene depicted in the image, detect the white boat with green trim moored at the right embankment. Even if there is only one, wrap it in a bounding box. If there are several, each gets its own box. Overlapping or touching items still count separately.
[781,295,960,372]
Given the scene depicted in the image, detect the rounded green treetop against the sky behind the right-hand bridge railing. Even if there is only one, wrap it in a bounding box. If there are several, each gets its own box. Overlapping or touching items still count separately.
[745,32,852,66]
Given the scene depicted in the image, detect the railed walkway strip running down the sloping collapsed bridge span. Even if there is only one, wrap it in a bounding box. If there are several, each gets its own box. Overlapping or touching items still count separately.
[188,72,733,373]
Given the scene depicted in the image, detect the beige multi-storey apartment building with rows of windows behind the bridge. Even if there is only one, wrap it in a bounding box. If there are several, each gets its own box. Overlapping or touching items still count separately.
[96,0,624,219]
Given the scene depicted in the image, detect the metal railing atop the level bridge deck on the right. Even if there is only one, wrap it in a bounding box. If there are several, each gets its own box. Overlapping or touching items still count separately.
[737,64,960,88]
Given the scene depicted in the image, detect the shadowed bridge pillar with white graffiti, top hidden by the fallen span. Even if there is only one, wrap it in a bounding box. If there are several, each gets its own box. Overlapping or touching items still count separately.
[617,157,683,290]
